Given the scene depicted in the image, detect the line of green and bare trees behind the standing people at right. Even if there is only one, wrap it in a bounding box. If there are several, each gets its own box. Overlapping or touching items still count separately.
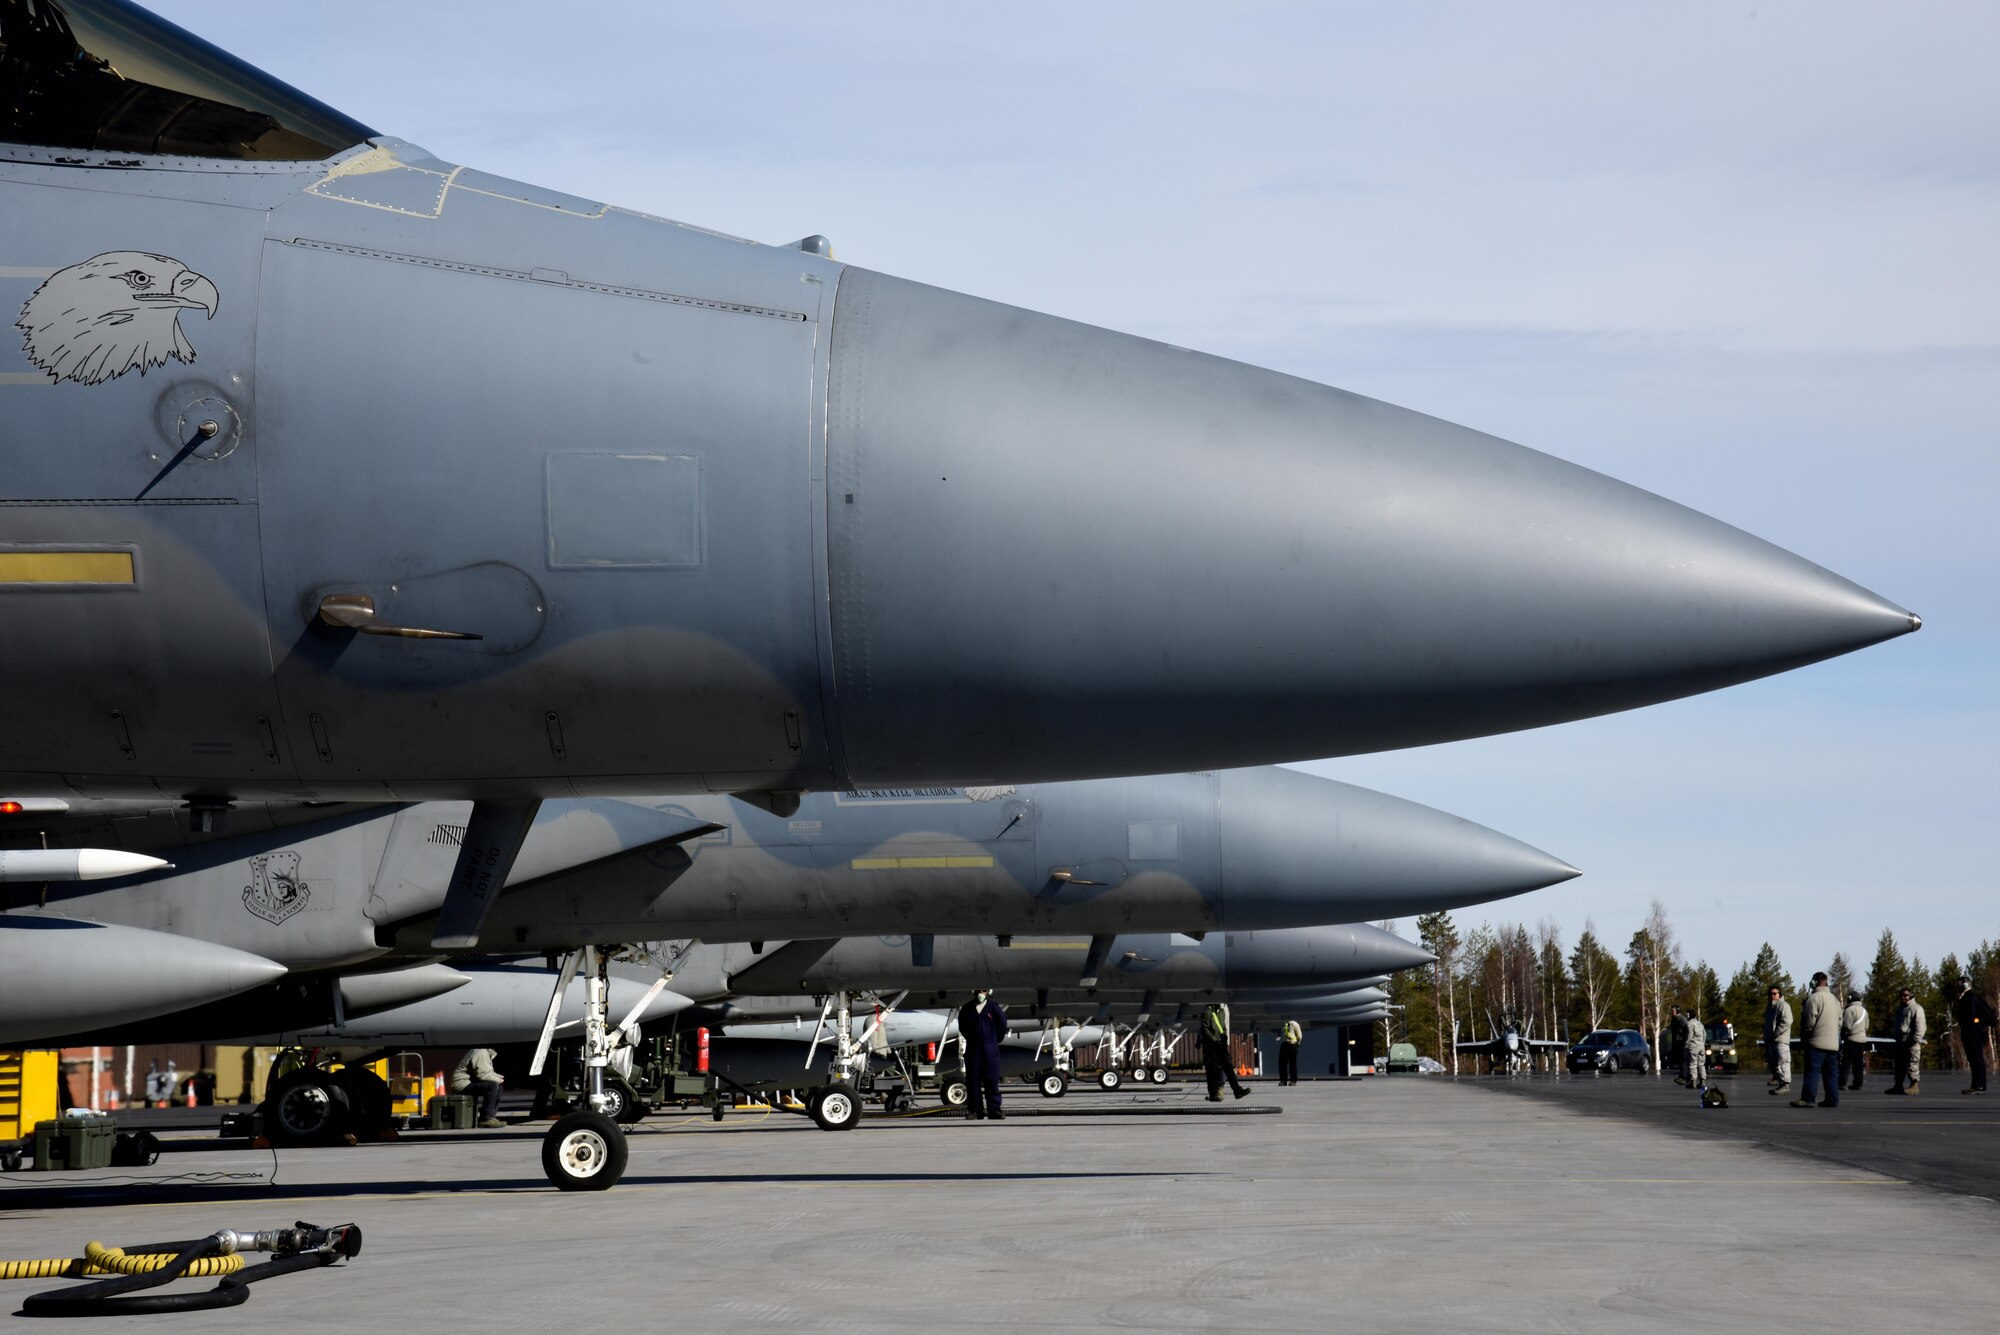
[1384,899,2000,1067]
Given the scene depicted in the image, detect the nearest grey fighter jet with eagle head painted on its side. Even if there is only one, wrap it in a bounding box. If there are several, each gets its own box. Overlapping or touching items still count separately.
[0,0,1918,839]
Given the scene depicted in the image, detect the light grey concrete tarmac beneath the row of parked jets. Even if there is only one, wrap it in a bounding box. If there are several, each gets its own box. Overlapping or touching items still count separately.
[0,1077,2000,1333]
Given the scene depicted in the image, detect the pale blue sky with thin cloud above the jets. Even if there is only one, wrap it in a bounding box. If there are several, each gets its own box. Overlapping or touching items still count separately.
[158,0,2000,973]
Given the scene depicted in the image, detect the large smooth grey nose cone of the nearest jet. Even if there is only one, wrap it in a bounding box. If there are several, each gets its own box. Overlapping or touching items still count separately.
[826,268,1916,785]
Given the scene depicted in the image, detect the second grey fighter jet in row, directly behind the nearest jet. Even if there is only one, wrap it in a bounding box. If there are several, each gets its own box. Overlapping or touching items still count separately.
[0,769,1576,1037]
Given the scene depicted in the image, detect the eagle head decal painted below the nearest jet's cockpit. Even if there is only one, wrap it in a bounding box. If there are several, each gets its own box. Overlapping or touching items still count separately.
[14,250,222,386]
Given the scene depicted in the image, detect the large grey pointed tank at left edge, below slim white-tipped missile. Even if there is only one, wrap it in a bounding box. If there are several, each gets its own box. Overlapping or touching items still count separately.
[0,913,286,1043]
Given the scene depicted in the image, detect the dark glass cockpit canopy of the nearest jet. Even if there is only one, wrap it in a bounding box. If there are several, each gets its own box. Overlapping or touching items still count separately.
[0,0,374,162]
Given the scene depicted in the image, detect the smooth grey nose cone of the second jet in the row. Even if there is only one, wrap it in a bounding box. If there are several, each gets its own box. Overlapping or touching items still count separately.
[1218,767,1576,927]
